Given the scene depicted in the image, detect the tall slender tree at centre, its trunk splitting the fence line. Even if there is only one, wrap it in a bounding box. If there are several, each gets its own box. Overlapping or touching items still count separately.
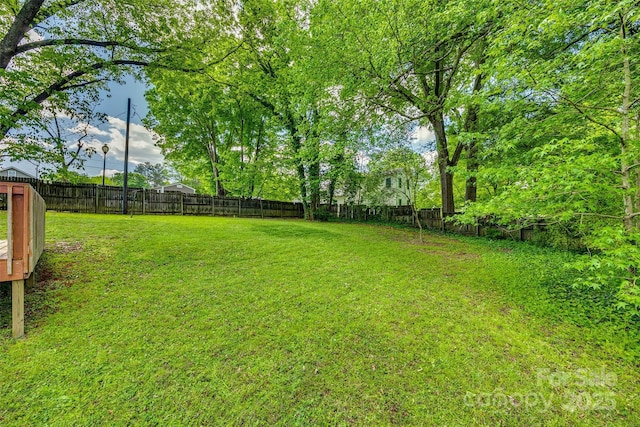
[228,1,324,219]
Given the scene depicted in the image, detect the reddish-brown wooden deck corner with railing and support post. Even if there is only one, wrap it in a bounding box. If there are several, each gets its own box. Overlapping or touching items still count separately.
[0,182,46,338]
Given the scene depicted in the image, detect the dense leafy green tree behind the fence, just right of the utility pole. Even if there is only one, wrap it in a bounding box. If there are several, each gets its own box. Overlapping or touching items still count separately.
[146,65,290,197]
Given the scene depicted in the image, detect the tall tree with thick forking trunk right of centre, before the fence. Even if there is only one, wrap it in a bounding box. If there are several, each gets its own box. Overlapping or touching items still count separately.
[319,1,497,214]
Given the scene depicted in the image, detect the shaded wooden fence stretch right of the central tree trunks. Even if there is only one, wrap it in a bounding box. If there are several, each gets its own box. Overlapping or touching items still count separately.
[325,205,544,241]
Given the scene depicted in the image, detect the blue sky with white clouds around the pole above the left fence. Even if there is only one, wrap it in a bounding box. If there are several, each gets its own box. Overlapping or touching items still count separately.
[2,76,163,176]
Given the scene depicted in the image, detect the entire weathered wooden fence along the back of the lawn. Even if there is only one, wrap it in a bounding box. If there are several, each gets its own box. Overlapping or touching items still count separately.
[0,177,544,240]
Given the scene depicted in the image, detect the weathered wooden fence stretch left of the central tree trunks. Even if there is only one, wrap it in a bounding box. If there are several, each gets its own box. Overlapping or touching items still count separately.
[0,178,304,218]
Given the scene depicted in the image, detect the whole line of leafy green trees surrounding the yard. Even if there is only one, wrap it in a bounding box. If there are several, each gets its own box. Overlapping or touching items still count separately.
[0,0,640,309]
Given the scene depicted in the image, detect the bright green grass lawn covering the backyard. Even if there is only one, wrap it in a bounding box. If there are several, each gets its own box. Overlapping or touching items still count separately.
[0,213,640,426]
